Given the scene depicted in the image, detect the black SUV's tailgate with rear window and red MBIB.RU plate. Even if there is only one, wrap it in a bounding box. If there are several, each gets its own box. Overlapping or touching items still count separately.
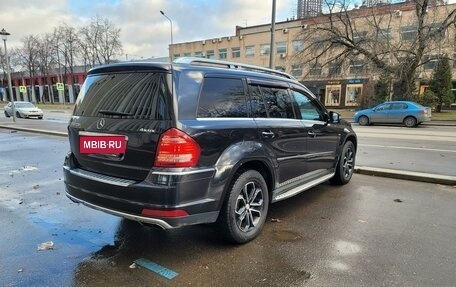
[68,69,172,180]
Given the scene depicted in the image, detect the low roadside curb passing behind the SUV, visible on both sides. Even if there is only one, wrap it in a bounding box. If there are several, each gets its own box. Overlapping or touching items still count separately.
[0,125,456,186]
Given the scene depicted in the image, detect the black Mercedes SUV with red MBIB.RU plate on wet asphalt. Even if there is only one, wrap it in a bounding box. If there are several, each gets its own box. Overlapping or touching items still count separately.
[63,58,357,243]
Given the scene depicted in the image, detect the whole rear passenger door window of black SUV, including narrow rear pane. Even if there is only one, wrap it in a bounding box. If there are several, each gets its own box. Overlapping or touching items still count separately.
[250,86,296,119]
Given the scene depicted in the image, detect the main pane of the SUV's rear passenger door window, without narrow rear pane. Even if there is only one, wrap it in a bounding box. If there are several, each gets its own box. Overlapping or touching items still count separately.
[259,86,296,119]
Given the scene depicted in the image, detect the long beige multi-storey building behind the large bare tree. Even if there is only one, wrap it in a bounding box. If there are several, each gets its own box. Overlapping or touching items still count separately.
[170,2,456,108]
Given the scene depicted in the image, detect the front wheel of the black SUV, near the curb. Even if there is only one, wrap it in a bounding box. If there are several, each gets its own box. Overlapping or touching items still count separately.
[331,141,356,185]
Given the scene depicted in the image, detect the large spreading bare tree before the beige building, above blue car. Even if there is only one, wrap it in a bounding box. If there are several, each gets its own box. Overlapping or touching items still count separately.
[294,0,456,98]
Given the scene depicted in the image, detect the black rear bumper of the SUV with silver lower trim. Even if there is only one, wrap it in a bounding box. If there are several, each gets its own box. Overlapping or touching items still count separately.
[63,155,220,229]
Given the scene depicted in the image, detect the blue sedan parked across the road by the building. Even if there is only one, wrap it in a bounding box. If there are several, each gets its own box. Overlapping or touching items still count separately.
[353,101,432,128]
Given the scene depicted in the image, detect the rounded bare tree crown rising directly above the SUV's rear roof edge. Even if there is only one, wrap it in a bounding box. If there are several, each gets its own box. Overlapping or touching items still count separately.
[79,15,122,66]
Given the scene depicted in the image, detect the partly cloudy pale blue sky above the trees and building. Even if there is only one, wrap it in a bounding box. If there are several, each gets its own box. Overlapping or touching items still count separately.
[0,0,296,60]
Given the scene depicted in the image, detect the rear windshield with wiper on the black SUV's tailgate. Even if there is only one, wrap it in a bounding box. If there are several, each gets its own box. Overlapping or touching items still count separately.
[74,73,170,120]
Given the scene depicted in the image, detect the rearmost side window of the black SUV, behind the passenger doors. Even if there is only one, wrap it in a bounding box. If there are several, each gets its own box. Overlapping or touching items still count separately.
[198,78,249,118]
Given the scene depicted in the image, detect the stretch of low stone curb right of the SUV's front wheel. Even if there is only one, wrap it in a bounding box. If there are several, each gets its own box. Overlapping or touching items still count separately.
[355,166,456,186]
